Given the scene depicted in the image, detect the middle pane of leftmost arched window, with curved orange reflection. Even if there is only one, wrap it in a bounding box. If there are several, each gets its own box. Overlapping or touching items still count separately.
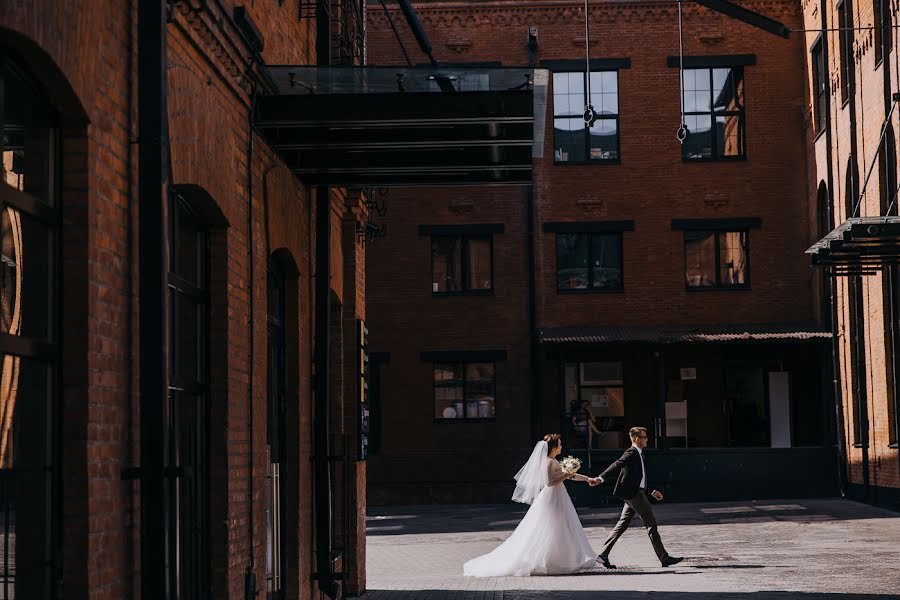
[0,206,53,338]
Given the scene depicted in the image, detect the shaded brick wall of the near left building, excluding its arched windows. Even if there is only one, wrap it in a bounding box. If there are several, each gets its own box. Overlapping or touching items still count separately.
[0,0,365,599]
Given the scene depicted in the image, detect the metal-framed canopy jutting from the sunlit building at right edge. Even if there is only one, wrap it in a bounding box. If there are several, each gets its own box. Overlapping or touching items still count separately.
[806,216,900,275]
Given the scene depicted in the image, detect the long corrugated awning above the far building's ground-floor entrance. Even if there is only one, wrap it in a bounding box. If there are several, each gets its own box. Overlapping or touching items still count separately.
[539,323,831,344]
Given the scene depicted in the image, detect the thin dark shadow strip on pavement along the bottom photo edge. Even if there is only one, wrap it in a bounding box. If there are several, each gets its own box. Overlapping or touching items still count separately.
[360,590,897,600]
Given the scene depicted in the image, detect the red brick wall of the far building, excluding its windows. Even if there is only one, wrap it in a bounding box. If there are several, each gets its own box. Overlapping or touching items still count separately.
[367,1,819,502]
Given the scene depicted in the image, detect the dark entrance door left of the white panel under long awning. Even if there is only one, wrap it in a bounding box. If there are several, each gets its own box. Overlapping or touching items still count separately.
[723,366,769,446]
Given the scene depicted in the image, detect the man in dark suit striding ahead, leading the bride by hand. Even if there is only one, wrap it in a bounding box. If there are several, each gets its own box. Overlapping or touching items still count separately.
[588,427,684,569]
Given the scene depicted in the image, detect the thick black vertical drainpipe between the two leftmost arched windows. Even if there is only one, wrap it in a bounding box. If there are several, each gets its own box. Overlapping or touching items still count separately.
[137,2,175,599]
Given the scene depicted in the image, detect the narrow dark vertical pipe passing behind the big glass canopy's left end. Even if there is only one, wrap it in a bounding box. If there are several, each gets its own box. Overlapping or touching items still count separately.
[313,0,337,598]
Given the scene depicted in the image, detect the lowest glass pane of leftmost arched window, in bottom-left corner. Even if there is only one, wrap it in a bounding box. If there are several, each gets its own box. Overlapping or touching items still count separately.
[0,354,52,598]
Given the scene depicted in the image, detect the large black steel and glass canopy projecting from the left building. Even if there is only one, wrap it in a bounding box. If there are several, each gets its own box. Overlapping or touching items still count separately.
[254,66,547,187]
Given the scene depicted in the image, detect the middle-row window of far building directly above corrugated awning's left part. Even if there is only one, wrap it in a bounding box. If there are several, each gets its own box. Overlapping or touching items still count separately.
[556,233,622,291]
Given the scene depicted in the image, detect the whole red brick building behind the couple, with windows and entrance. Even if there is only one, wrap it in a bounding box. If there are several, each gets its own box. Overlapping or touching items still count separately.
[367,1,837,503]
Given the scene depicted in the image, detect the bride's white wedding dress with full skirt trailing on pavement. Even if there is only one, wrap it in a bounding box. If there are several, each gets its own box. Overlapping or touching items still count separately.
[463,452,597,577]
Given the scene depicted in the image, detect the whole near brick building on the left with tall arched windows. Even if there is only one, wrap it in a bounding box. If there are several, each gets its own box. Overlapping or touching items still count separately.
[0,0,366,600]
